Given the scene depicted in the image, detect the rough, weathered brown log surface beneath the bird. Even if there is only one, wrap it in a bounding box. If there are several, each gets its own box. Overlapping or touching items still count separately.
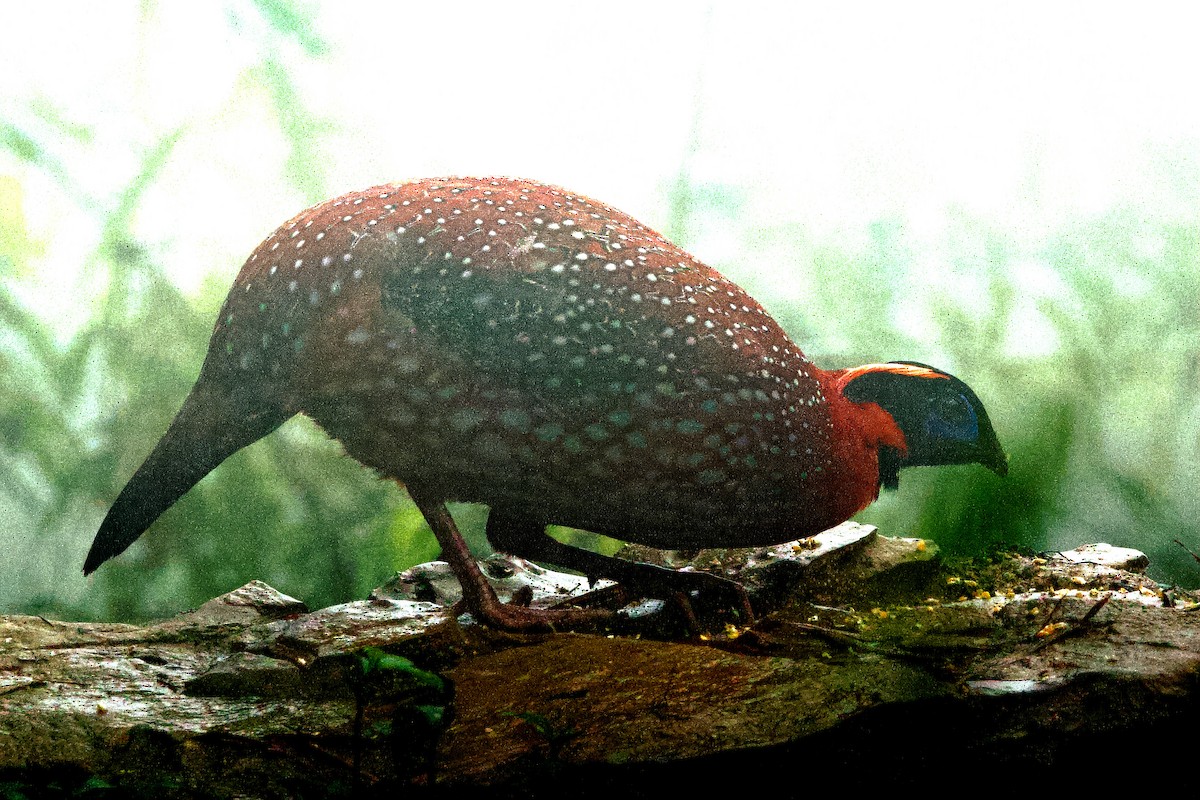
[0,523,1200,798]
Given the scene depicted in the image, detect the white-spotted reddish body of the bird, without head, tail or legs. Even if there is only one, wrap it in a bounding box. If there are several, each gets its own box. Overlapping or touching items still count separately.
[200,179,887,547]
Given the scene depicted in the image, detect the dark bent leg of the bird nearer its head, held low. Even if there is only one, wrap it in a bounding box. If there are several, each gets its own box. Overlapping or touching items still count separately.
[487,509,754,626]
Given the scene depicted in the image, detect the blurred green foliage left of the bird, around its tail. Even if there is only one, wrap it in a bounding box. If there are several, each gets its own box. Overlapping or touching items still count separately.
[0,0,422,619]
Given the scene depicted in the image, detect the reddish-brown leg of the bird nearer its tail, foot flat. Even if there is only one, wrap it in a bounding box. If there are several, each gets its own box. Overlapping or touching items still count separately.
[407,485,612,631]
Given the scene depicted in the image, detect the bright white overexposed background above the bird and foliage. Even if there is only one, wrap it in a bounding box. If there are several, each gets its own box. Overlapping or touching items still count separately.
[0,1,1200,330]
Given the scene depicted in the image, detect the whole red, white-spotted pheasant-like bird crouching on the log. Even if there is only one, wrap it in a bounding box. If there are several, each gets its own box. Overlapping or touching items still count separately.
[84,178,1008,630]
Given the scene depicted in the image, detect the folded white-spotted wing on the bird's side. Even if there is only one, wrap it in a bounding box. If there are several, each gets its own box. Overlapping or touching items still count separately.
[382,194,787,412]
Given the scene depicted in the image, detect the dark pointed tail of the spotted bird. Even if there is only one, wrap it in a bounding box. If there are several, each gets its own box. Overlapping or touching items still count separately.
[83,379,292,575]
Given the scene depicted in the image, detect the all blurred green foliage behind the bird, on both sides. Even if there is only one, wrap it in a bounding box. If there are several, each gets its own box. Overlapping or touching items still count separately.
[0,0,1200,620]
